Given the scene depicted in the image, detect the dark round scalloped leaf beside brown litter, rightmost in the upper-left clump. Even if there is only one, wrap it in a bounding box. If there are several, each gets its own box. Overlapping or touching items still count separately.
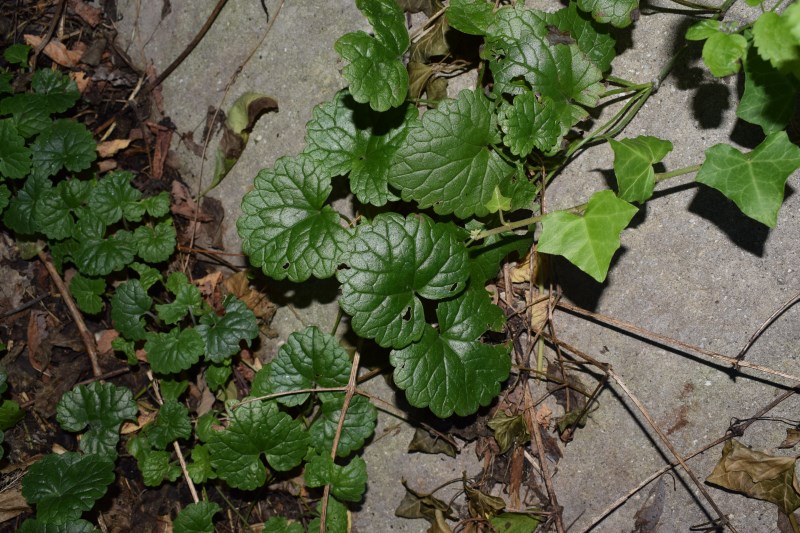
[31,119,97,177]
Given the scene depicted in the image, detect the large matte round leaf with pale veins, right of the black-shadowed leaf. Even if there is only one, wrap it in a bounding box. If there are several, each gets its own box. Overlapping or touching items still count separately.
[389,90,514,218]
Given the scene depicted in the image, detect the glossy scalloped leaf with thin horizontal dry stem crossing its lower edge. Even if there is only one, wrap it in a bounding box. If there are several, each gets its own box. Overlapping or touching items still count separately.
[267,326,352,406]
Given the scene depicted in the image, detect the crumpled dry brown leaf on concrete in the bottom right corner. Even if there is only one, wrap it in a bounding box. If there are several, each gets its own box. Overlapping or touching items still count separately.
[706,439,800,515]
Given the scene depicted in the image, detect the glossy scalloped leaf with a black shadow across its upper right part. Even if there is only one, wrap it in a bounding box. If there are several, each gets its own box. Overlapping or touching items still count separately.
[306,91,417,206]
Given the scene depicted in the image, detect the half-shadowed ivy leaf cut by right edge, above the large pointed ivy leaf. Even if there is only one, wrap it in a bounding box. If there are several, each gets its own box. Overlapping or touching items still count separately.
[736,47,798,135]
